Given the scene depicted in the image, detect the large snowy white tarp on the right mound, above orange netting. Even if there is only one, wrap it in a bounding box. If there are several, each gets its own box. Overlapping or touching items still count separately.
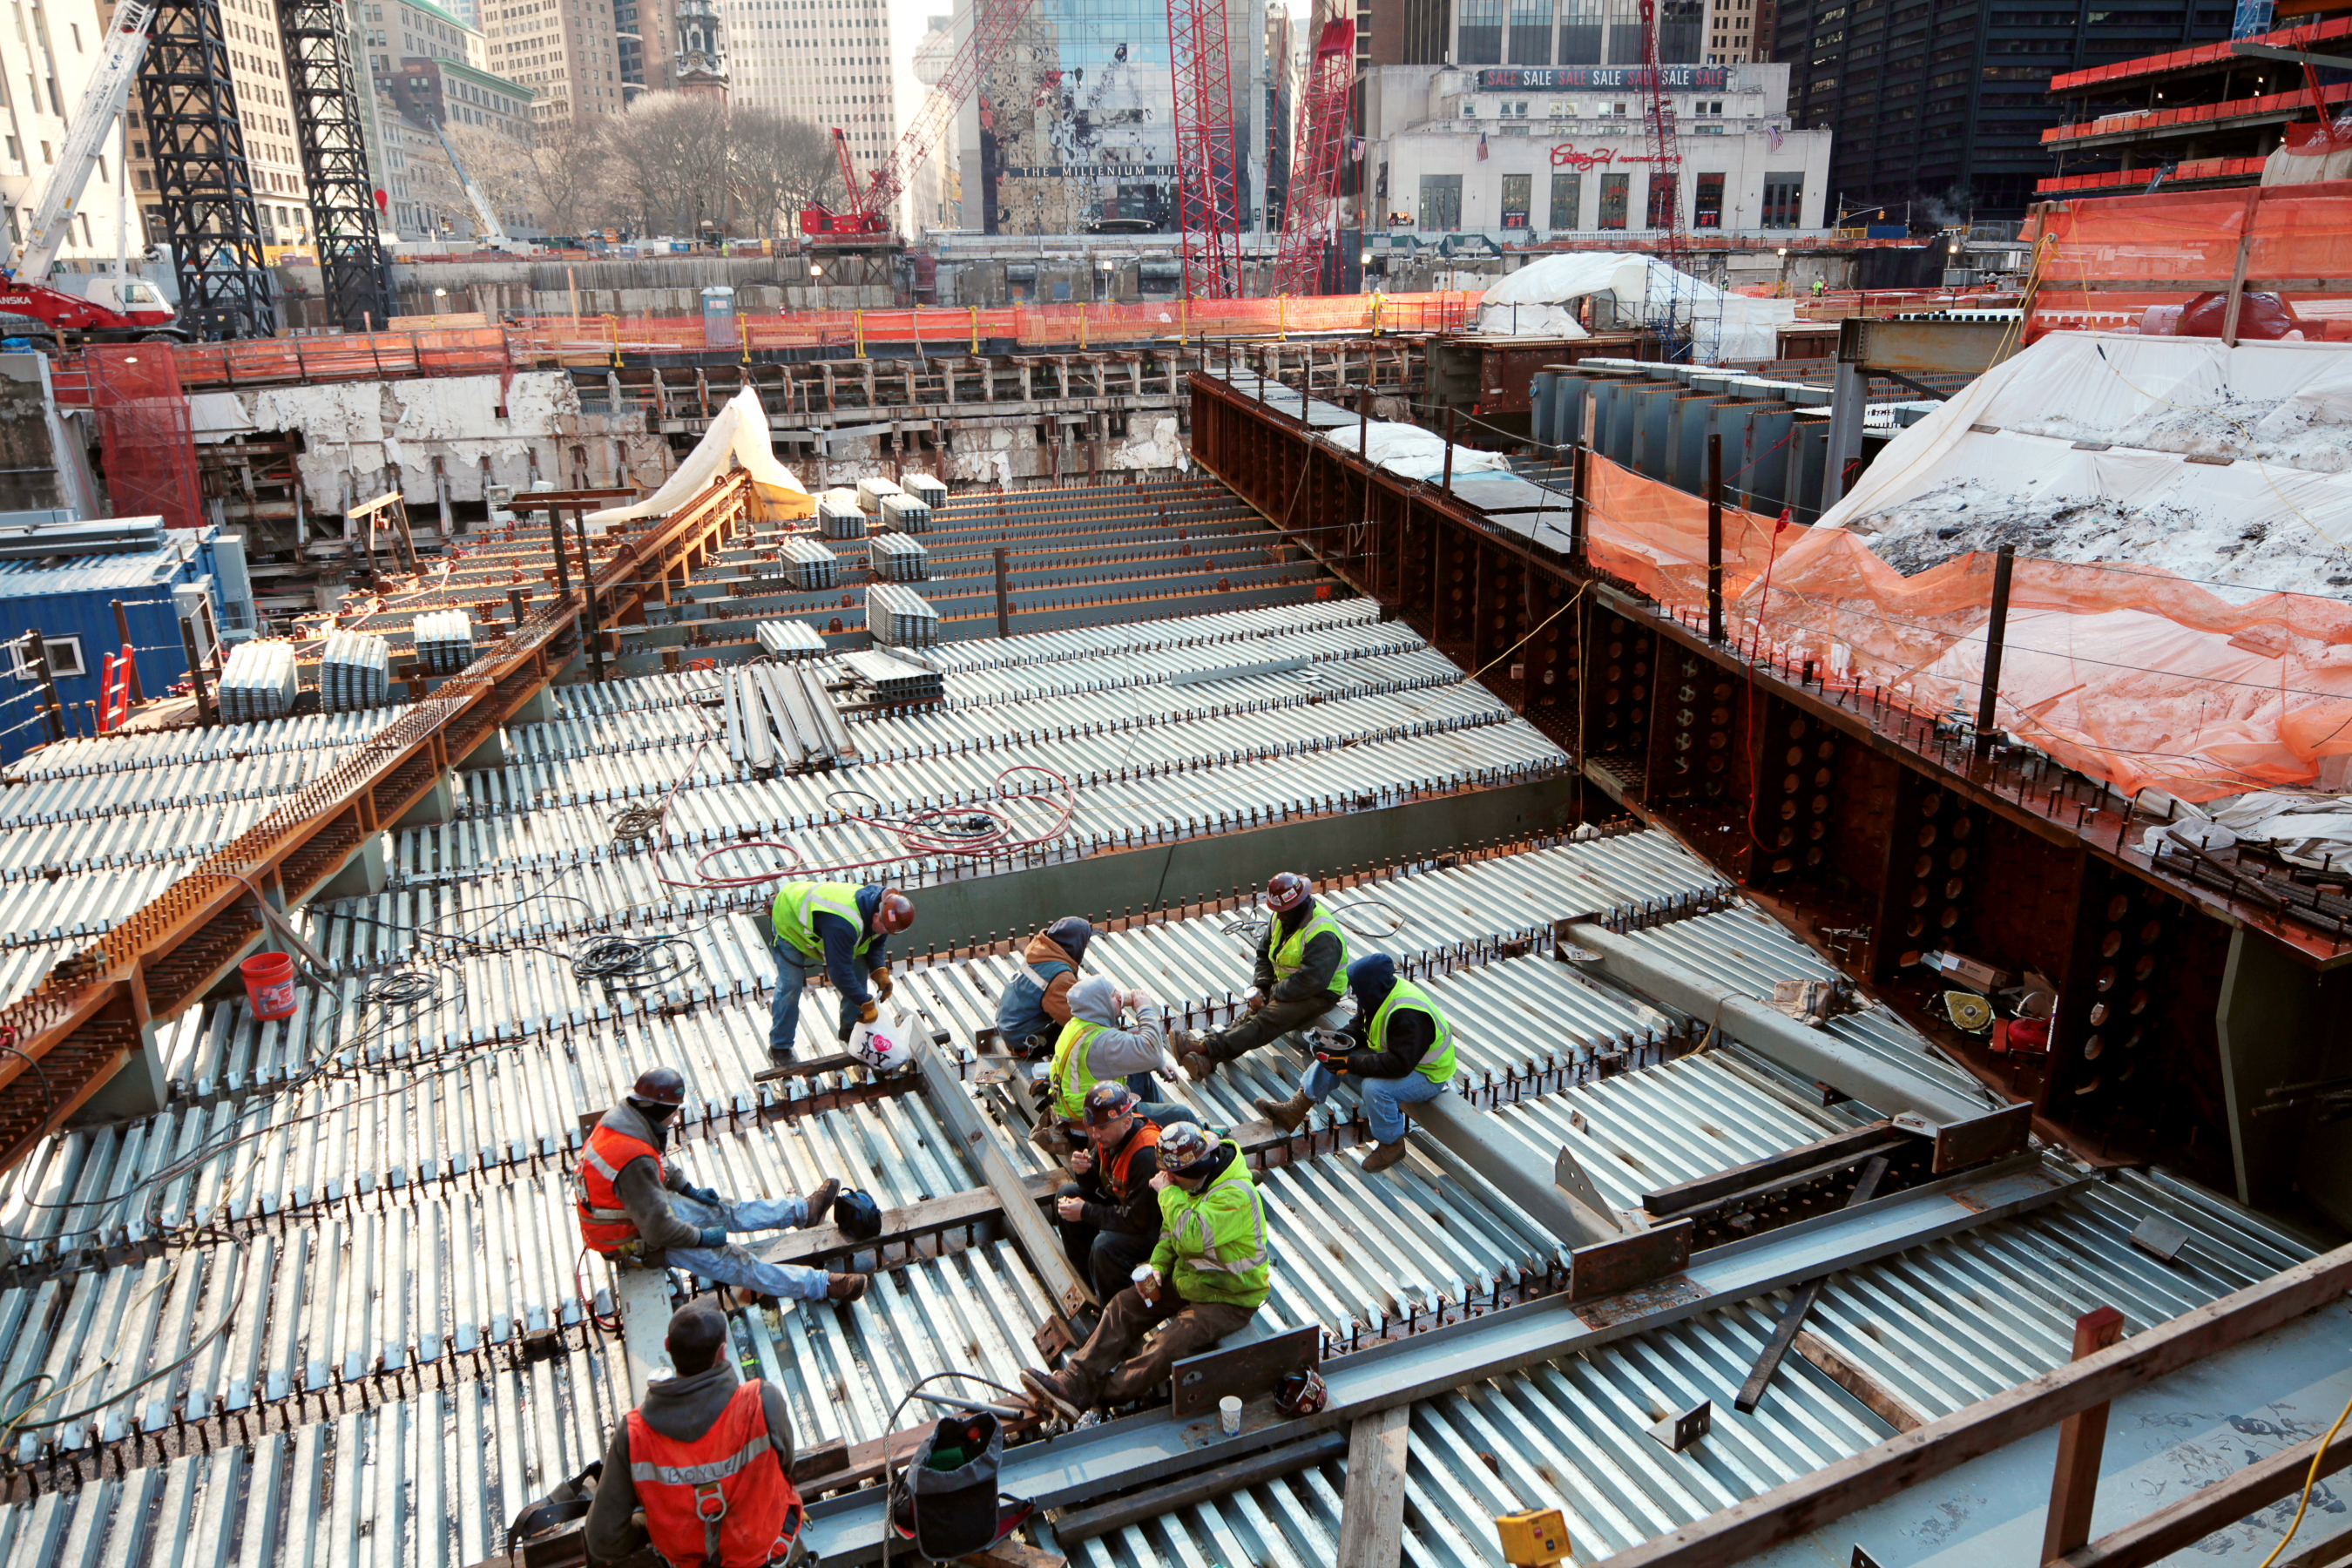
[1821,332,2352,597]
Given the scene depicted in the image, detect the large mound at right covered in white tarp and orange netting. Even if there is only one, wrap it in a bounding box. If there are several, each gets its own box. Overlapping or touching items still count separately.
[1552,334,2352,803]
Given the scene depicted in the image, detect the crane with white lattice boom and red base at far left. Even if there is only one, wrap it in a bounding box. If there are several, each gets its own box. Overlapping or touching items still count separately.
[0,0,186,348]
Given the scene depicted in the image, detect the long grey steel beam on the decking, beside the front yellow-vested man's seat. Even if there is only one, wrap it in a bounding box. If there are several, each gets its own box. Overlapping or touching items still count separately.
[804,1146,2089,1564]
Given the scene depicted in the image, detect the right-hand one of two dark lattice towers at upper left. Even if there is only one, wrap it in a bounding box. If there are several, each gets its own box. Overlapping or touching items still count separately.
[278,0,393,332]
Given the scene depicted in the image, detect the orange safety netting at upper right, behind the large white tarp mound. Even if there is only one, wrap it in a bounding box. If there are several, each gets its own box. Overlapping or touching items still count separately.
[2023,181,2352,336]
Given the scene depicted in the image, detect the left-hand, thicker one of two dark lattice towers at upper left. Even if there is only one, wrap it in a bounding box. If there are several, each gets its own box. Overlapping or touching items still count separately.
[139,0,278,341]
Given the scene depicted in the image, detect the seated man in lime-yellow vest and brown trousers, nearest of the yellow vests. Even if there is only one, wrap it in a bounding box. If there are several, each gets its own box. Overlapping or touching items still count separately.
[1021,1121,1273,1423]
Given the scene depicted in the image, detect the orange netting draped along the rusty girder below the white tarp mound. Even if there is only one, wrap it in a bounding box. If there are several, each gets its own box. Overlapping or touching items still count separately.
[1588,456,2352,801]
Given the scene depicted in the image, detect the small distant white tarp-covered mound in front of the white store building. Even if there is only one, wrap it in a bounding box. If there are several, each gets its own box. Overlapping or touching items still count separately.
[1477,252,1797,364]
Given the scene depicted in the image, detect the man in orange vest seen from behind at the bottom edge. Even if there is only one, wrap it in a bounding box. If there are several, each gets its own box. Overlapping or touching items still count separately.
[581,1302,807,1568]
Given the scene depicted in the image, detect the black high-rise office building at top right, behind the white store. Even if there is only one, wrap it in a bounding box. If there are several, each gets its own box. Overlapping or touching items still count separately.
[1774,0,2232,223]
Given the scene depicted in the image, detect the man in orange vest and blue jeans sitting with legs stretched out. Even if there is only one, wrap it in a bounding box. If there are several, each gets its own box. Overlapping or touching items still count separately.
[574,1067,866,1305]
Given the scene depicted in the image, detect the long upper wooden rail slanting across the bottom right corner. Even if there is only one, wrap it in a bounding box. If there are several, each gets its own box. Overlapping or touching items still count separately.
[1609,1246,2352,1568]
